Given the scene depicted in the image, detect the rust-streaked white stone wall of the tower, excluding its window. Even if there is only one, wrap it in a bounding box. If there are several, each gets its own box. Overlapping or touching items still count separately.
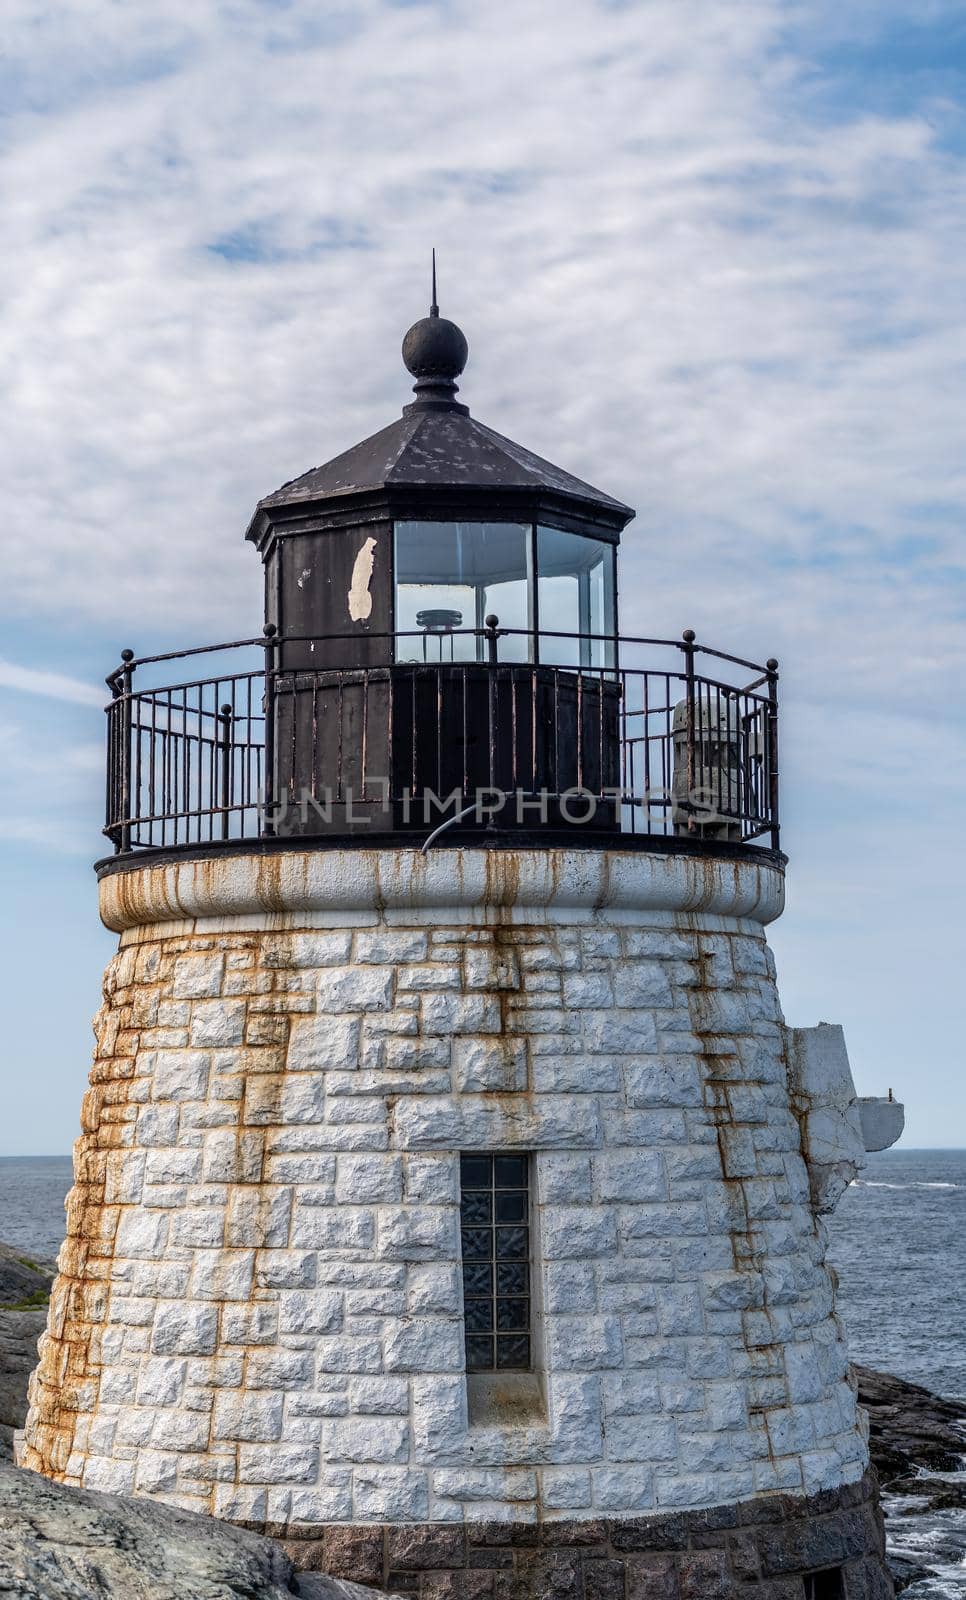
[21,850,867,1525]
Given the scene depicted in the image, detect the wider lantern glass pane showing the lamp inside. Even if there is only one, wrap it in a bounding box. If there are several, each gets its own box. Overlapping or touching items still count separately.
[395,522,531,661]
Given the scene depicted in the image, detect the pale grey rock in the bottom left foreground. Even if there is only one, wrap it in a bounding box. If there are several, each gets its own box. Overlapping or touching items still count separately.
[0,1464,385,1600]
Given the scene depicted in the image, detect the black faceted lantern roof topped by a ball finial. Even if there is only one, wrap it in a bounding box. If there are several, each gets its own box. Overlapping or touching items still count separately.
[248,283,633,544]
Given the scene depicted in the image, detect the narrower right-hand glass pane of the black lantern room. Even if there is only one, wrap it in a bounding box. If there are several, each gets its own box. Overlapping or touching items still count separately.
[537,528,616,667]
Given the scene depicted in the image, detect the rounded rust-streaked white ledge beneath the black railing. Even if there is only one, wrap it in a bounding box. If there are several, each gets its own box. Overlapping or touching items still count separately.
[99,848,784,933]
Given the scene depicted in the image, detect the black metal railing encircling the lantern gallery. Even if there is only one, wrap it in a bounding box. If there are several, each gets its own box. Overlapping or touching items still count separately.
[104,619,779,854]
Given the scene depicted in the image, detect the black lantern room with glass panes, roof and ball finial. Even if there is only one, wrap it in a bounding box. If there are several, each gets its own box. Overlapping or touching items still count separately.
[249,291,633,835]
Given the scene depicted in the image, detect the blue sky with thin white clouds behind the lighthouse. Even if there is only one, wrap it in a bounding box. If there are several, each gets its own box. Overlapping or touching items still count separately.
[0,0,966,1154]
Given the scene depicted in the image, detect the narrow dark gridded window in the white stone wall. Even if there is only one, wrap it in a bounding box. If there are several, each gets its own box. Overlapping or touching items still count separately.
[459,1152,531,1373]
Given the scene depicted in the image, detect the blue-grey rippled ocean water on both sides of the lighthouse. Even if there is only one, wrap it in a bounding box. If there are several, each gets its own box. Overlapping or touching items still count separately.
[0,1149,966,1600]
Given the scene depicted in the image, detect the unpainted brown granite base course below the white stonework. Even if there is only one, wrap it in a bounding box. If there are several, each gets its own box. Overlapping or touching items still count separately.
[276,1472,894,1600]
